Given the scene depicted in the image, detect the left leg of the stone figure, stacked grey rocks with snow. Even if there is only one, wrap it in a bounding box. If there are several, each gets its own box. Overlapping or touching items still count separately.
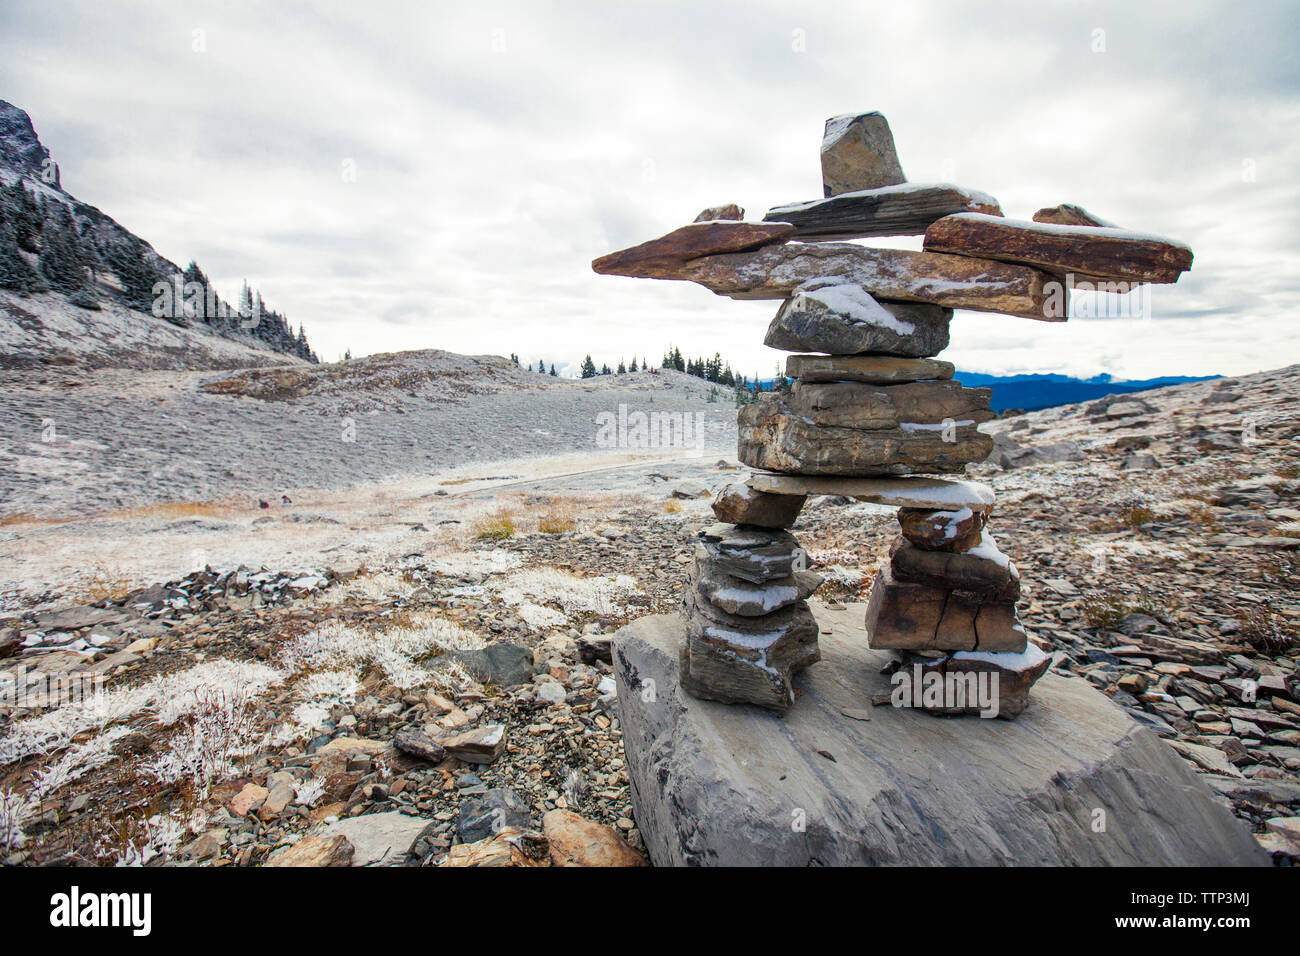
[681,484,822,711]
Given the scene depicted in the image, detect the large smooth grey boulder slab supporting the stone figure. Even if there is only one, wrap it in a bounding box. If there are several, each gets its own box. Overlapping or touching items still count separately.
[614,605,1268,866]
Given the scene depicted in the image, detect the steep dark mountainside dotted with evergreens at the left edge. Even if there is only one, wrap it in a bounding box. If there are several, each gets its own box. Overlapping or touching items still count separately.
[0,100,316,368]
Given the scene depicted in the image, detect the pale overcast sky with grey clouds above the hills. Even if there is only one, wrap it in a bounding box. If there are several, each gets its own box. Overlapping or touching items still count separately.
[0,0,1300,377]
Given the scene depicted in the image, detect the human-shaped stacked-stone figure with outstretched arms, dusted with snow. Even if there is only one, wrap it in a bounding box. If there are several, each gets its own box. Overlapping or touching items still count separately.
[592,113,1192,717]
